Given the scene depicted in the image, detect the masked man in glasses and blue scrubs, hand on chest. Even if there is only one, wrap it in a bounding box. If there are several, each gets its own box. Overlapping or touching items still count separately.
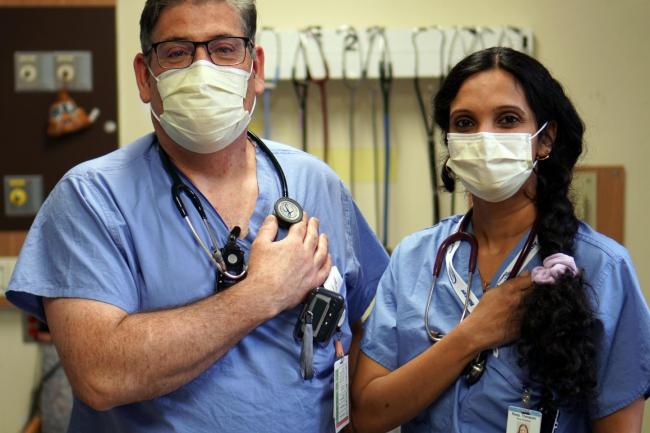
[7,0,387,432]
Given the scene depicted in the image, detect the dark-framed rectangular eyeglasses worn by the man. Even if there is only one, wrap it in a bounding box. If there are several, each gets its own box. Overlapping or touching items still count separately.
[147,36,250,69]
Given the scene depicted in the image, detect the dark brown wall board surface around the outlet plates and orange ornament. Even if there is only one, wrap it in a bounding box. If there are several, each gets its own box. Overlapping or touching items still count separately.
[0,3,118,231]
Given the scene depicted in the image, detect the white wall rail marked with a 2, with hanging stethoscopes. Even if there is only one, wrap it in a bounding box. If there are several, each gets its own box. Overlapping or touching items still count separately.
[256,26,534,80]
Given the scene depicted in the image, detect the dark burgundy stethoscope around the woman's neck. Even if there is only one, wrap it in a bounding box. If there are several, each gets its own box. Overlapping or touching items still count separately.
[424,209,536,385]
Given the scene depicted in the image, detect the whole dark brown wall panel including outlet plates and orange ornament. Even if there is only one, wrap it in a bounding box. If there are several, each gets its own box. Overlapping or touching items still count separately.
[0,6,117,231]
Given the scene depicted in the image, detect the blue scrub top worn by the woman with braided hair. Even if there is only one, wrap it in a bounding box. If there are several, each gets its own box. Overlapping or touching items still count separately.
[361,216,650,433]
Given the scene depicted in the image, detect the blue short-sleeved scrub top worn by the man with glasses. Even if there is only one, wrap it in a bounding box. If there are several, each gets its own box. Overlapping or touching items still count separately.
[7,135,388,433]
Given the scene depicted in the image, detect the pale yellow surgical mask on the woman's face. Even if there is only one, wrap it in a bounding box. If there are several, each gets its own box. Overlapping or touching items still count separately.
[447,123,546,203]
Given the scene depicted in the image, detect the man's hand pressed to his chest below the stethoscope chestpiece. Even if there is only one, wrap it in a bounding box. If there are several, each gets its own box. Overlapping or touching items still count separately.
[246,214,332,314]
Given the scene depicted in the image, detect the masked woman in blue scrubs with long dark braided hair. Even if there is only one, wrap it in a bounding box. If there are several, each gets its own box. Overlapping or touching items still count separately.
[352,48,650,433]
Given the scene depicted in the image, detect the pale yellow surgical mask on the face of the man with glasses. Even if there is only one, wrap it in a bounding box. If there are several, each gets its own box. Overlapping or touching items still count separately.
[150,60,257,153]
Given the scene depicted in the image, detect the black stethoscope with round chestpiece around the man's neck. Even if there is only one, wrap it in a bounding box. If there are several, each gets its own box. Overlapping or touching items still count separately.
[159,131,303,289]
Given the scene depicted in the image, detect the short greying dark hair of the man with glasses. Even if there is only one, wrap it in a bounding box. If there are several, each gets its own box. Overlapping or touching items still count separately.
[140,0,257,54]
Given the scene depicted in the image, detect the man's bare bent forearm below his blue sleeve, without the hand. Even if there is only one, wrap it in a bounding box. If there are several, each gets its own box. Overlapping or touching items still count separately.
[46,282,272,410]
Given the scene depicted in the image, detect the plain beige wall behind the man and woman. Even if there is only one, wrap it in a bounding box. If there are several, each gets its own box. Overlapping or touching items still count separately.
[0,0,650,433]
